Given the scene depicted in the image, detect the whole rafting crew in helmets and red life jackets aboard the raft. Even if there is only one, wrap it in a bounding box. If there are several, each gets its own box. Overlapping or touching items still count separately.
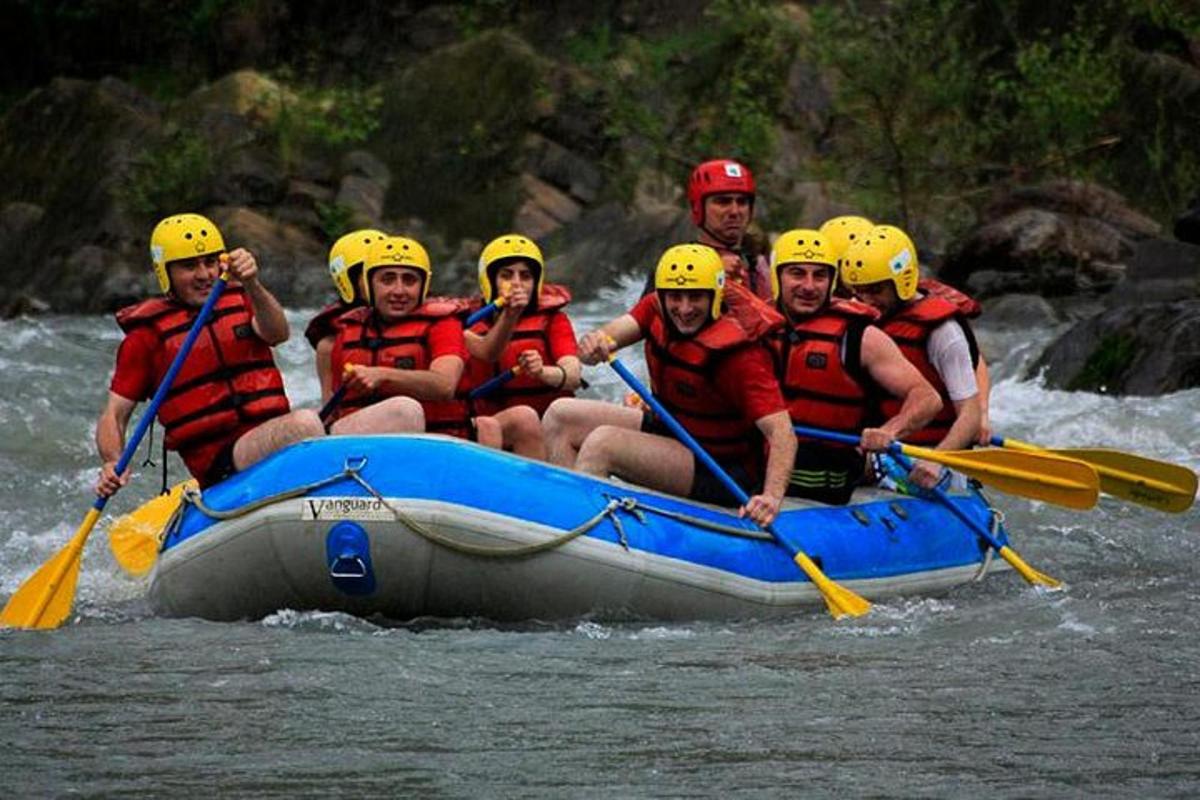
[96,160,990,524]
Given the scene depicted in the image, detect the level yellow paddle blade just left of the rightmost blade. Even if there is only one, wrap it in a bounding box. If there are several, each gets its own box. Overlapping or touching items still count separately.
[900,445,1100,509]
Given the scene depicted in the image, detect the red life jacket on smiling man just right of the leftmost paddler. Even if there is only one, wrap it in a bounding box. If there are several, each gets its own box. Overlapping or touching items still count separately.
[330,299,470,439]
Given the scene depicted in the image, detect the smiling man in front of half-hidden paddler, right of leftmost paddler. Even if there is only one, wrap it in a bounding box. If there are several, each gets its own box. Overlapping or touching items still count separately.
[330,236,499,446]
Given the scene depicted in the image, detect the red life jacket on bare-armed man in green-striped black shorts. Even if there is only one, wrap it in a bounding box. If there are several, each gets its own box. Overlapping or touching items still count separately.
[770,299,878,434]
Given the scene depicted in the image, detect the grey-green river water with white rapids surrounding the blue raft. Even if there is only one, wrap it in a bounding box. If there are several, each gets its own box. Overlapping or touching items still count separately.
[0,280,1200,798]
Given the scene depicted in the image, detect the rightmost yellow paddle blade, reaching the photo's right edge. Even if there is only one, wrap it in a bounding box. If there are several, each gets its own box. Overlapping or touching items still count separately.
[1046,447,1196,513]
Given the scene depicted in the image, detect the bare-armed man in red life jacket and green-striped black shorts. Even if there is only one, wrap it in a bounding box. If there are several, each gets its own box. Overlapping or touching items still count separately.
[769,229,942,505]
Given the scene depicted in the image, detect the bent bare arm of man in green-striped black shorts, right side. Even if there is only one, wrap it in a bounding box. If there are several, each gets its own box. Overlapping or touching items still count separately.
[862,325,942,451]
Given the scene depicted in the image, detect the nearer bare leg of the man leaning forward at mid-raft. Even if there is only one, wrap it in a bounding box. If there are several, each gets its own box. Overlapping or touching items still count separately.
[575,425,696,497]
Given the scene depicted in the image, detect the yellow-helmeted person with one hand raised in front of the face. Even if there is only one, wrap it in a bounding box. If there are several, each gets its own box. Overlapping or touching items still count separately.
[466,234,581,459]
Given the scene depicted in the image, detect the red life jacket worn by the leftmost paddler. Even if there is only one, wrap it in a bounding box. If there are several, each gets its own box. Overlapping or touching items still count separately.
[116,287,290,486]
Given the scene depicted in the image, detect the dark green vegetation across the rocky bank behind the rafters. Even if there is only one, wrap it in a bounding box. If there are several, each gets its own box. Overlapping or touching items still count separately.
[0,0,1200,251]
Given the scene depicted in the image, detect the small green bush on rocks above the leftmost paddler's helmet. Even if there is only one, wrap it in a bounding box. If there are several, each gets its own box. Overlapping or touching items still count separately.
[116,131,216,219]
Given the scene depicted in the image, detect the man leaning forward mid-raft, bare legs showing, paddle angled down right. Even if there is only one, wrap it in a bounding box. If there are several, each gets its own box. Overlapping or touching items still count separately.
[544,245,796,532]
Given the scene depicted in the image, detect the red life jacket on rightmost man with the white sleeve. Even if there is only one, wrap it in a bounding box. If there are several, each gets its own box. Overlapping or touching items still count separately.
[878,296,979,445]
